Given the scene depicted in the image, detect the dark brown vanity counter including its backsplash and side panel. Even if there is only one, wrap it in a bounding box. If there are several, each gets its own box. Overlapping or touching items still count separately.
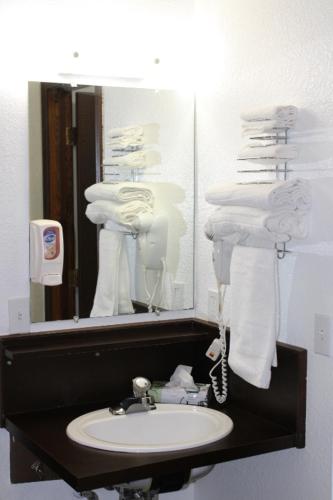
[0,320,306,491]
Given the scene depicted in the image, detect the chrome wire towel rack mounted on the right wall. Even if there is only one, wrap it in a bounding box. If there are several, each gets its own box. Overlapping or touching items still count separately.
[237,128,293,260]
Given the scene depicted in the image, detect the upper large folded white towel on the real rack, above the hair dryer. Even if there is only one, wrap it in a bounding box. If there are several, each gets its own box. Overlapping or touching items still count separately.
[206,179,311,210]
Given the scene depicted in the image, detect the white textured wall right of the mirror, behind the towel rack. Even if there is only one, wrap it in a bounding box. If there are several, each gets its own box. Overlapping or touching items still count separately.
[195,0,333,500]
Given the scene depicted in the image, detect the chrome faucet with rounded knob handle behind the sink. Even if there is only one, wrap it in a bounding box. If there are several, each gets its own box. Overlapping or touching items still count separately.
[110,377,156,415]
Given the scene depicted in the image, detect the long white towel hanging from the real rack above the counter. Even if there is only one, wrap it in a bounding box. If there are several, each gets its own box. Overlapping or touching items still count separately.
[228,246,279,389]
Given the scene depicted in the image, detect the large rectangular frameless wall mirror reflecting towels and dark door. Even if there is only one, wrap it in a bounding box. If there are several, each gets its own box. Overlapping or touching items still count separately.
[29,82,194,322]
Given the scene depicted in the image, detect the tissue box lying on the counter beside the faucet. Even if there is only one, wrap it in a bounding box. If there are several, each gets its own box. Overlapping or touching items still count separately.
[148,381,210,406]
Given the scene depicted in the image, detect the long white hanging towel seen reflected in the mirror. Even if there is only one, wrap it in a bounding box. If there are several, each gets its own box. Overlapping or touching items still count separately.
[90,229,134,318]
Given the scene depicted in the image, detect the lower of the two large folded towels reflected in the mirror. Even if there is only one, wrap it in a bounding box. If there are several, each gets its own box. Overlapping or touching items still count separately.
[86,200,152,227]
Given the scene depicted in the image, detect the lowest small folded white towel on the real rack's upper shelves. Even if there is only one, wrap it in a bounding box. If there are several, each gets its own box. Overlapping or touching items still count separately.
[238,144,298,165]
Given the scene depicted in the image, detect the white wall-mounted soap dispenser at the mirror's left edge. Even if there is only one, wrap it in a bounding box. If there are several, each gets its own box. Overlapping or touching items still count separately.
[30,219,64,286]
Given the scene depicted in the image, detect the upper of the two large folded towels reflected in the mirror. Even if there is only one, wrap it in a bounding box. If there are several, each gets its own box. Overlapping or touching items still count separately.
[84,181,154,206]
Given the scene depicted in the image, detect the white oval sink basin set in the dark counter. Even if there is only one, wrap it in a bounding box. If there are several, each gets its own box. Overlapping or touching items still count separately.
[66,404,233,453]
